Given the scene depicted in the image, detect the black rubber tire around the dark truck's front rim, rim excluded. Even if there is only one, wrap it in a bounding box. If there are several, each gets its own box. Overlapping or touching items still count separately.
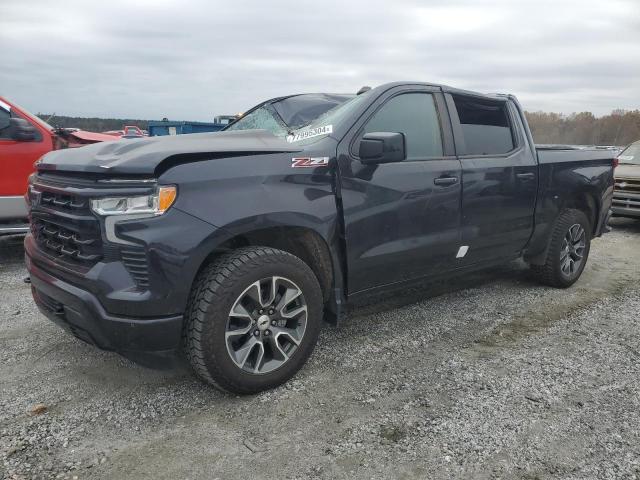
[183,247,323,394]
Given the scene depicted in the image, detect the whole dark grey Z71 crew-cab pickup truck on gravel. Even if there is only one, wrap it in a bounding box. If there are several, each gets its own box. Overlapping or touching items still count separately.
[25,82,615,393]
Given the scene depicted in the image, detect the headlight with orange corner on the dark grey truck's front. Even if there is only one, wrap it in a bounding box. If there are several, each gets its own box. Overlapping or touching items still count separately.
[91,185,177,216]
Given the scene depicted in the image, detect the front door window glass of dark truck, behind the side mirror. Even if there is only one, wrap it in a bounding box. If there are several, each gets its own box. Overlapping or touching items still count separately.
[364,93,442,160]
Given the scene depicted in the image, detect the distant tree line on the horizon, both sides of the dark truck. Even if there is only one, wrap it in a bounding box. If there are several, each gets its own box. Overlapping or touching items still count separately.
[39,110,640,145]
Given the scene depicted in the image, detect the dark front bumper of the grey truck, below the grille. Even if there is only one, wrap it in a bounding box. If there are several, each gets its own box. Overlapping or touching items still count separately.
[26,255,182,354]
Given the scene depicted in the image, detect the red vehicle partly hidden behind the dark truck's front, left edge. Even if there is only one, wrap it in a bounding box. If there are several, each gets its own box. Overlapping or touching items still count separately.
[0,97,118,235]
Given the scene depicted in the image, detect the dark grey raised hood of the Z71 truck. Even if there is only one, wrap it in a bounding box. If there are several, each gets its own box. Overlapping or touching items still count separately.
[37,130,300,176]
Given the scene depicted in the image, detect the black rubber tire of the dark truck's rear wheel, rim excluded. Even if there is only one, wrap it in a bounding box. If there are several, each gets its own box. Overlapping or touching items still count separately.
[531,209,592,288]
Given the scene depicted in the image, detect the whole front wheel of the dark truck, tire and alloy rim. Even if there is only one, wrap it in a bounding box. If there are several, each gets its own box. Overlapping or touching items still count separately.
[184,247,322,393]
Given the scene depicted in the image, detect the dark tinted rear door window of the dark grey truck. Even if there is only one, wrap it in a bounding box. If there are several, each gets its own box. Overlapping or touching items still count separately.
[453,95,515,155]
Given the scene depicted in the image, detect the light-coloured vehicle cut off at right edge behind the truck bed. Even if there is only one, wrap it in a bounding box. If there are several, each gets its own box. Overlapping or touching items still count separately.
[611,141,640,218]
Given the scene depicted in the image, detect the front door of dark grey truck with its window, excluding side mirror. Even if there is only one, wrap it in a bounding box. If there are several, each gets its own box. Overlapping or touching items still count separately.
[338,86,461,293]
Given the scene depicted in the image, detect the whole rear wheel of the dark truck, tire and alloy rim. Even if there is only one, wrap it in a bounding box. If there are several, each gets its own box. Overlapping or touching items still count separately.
[531,210,591,288]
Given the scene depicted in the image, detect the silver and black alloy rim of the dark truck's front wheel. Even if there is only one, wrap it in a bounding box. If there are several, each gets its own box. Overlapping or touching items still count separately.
[225,276,308,375]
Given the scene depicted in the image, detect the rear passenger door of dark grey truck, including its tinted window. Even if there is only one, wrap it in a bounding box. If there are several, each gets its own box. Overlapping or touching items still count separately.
[446,94,538,265]
